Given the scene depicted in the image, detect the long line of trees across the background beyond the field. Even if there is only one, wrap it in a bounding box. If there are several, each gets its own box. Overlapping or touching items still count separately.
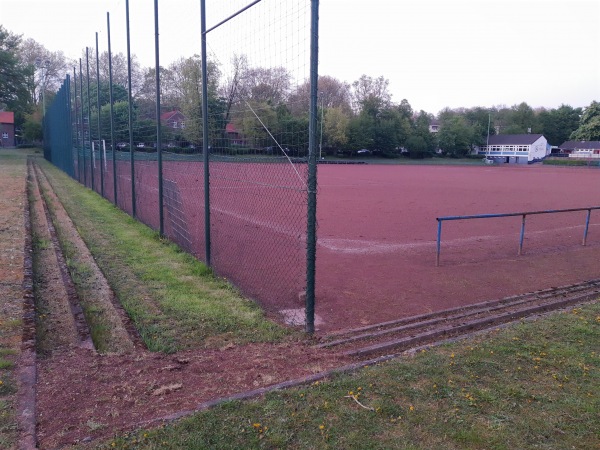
[0,25,600,158]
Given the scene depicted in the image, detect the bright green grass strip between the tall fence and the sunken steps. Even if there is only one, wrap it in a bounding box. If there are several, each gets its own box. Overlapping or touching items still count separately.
[39,160,292,352]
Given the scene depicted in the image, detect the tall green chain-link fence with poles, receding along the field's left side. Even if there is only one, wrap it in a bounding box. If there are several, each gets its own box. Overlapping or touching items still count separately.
[47,0,318,331]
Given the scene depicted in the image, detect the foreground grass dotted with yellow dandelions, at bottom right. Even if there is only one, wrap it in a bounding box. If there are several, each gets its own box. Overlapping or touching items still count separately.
[97,303,600,450]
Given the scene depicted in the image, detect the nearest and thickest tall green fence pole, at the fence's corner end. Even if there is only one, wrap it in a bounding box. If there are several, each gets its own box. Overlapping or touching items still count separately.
[306,0,319,333]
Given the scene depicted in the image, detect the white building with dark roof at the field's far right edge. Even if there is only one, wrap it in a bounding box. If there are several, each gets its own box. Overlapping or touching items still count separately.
[477,134,550,164]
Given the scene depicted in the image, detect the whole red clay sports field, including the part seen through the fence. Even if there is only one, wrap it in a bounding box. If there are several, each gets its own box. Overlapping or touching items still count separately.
[88,161,600,332]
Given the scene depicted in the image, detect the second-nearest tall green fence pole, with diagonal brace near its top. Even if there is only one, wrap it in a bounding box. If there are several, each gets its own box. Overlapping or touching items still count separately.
[200,0,211,267]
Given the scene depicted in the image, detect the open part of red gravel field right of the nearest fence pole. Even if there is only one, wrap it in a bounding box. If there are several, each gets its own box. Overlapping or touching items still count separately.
[316,165,600,332]
